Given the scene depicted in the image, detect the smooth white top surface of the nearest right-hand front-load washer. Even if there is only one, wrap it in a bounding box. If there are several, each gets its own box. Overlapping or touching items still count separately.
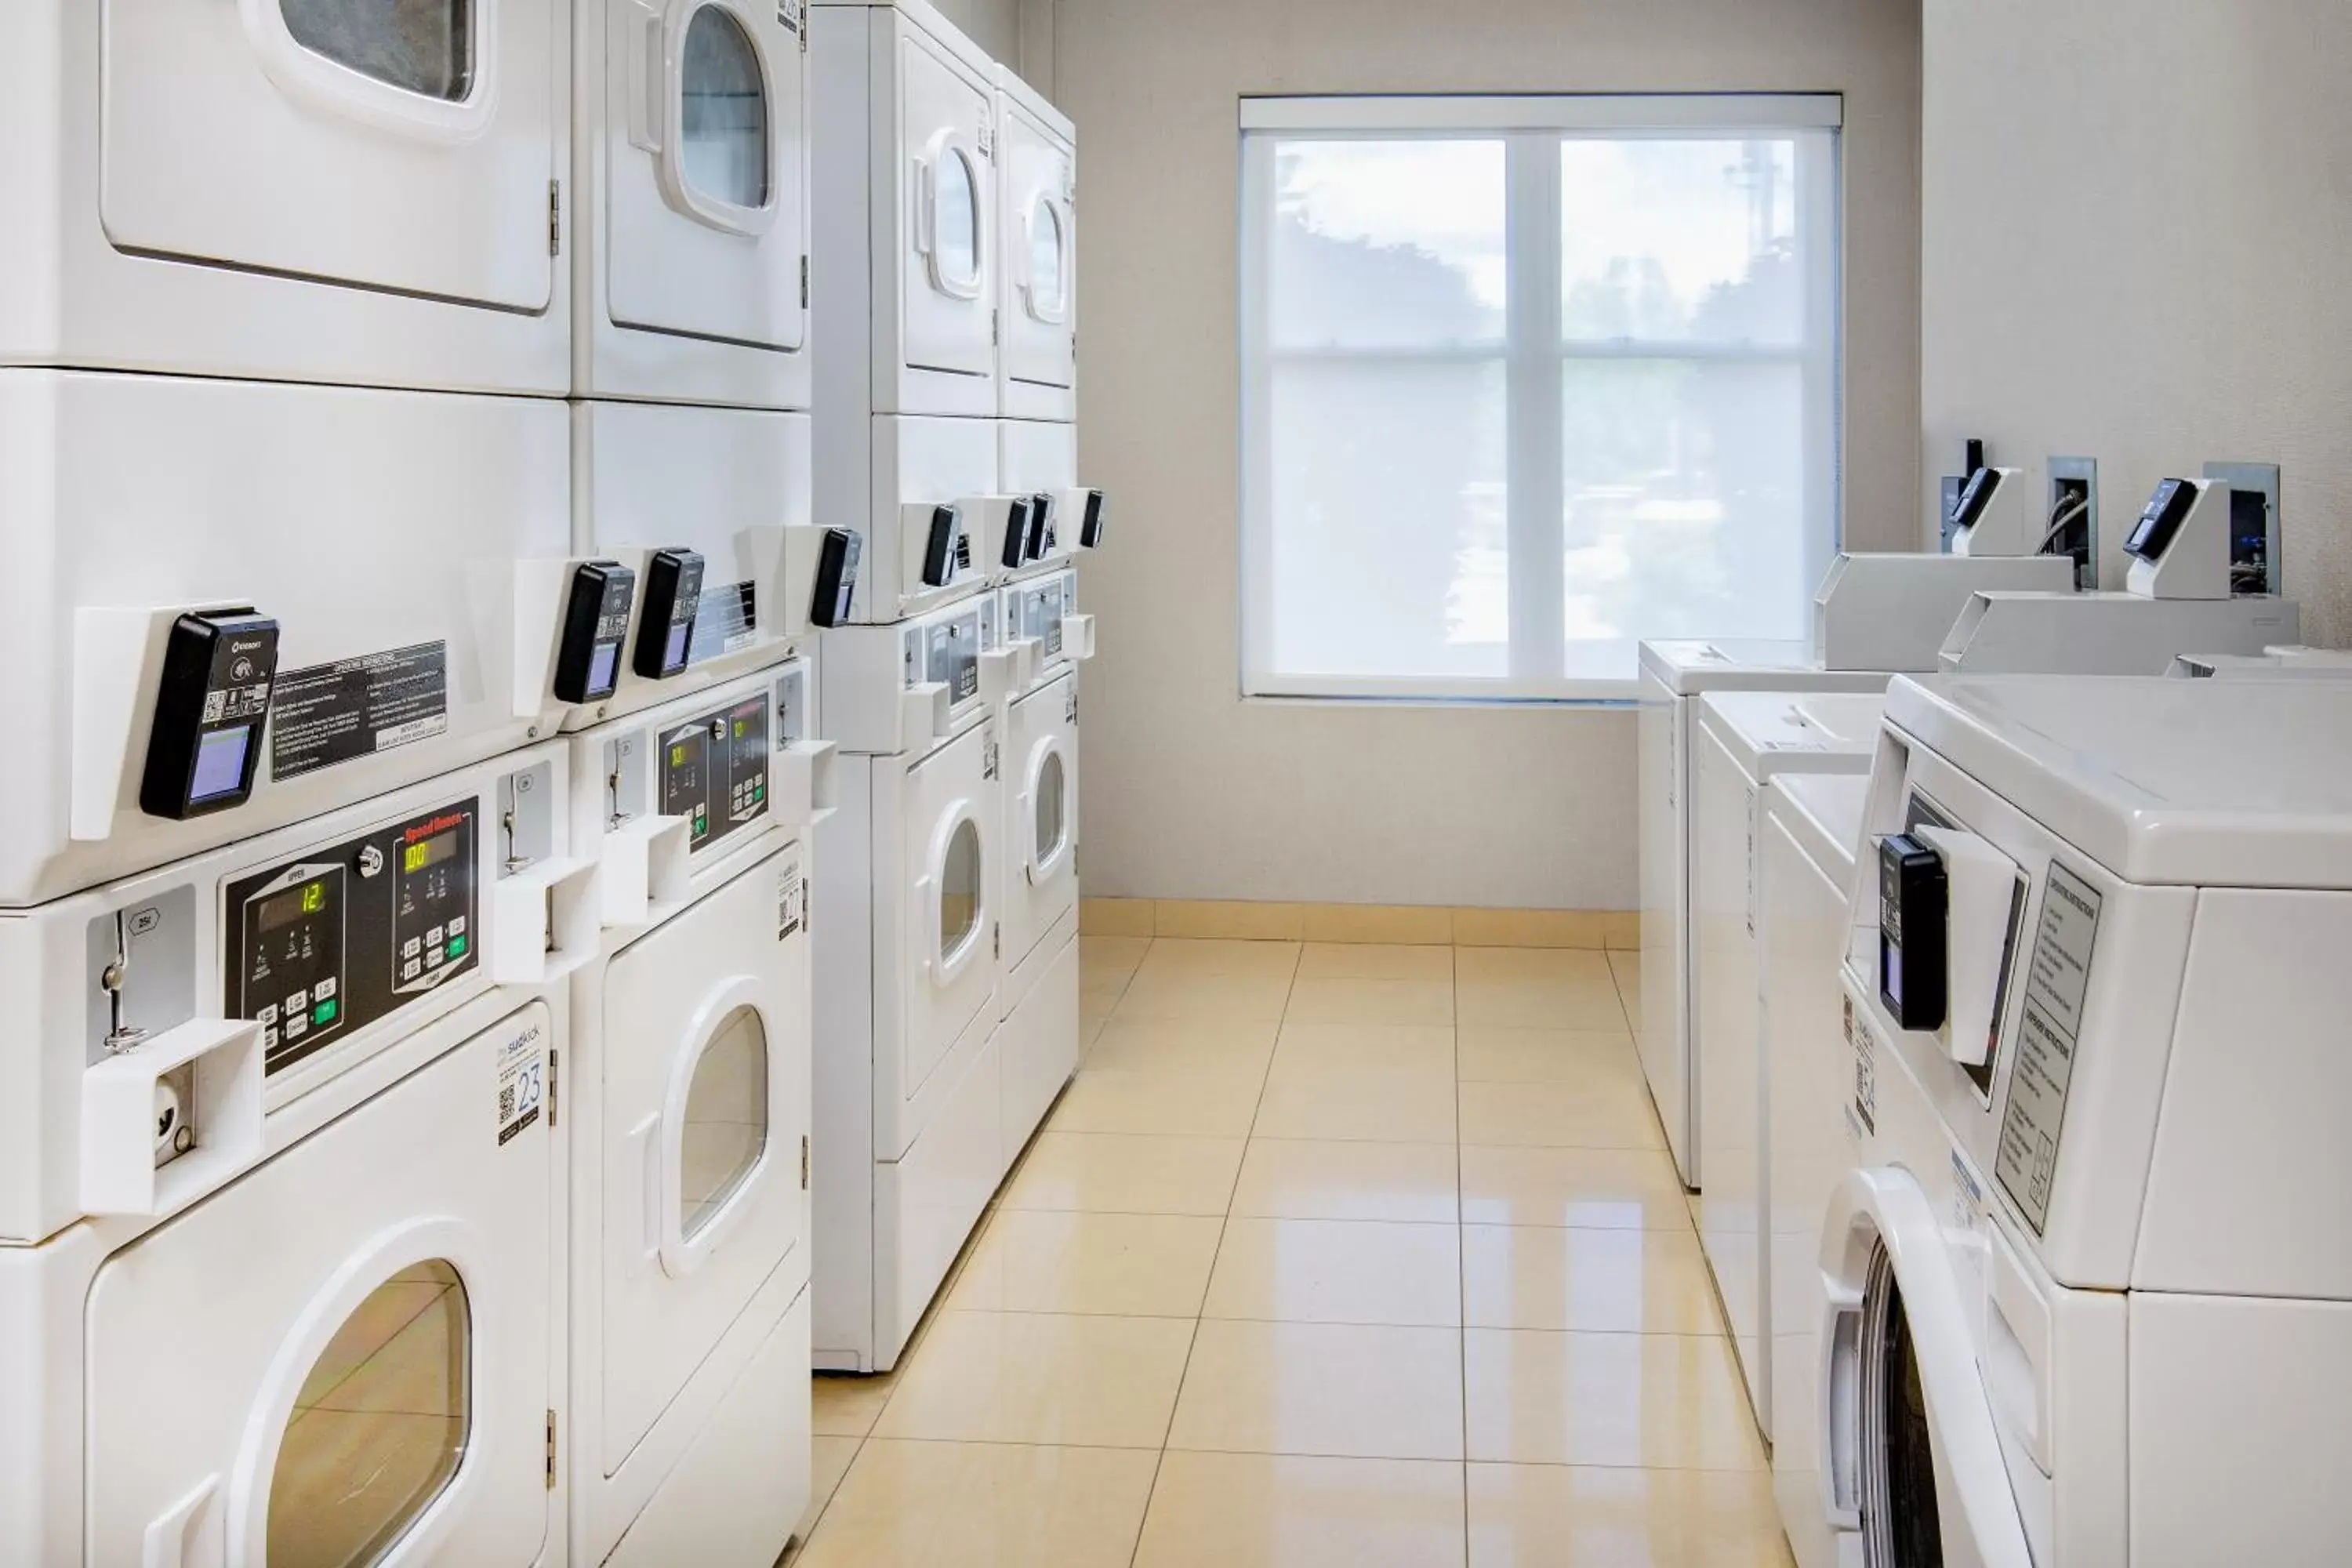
[1886,675,2352,888]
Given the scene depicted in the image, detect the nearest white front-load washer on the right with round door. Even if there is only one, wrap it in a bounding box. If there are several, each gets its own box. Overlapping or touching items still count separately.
[1818,677,2352,1568]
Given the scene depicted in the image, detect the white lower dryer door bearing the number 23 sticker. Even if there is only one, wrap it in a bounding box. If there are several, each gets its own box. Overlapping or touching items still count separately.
[85,1004,562,1568]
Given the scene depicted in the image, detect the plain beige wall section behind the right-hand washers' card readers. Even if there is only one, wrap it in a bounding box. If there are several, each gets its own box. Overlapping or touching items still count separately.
[1922,0,2352,644]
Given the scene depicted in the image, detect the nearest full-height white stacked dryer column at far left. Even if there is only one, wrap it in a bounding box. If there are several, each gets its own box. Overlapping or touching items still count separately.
[0,0,597,1566]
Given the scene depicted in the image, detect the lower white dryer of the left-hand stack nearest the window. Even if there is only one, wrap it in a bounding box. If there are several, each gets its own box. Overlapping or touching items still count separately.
[997,572,1094,1152]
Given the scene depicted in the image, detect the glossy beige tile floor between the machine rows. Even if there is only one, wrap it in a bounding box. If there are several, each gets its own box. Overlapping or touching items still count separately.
[790,935,1788,1568]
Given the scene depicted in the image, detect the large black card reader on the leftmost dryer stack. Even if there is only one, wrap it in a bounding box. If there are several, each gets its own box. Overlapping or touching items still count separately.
[139,604,278,820]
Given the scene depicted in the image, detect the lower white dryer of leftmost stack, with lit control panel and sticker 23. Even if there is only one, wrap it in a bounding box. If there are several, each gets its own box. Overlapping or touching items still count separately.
[0,746,595,1568]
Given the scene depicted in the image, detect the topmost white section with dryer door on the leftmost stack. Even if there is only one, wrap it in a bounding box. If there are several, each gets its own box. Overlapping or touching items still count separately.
[0,0,572,395]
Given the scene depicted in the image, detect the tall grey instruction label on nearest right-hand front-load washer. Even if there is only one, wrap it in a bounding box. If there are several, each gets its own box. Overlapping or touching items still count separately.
[1994,860,2100,1236]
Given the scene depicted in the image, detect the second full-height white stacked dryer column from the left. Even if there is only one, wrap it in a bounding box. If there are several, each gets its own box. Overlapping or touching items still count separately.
[560,0,858,1568]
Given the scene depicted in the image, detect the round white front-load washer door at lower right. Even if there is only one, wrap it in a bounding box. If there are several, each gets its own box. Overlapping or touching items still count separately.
[1820,1168,2032,1568]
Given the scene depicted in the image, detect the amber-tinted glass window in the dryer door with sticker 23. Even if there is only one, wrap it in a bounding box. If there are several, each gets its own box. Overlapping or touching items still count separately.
[268,1260,473,1568]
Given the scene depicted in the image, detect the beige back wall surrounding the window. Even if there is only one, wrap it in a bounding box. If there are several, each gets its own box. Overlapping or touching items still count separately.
[1058,0,1919,907]
